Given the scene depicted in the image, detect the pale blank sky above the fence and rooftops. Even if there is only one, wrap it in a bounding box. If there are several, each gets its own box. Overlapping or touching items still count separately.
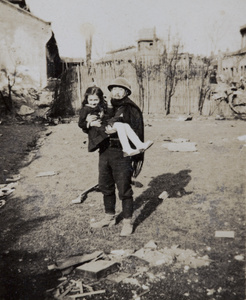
[26,0,246,59]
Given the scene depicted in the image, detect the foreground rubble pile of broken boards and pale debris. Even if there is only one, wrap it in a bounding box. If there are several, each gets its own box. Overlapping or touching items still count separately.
[46,240,212,299]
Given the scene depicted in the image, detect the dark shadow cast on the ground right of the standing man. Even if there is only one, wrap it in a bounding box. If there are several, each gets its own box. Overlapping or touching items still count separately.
[133,169,192,230]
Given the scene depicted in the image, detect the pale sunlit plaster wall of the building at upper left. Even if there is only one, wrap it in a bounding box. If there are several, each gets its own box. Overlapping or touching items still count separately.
[0,0,52,87]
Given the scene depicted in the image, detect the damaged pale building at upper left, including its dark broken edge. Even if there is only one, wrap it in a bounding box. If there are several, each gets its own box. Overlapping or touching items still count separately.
[0,0,61,88]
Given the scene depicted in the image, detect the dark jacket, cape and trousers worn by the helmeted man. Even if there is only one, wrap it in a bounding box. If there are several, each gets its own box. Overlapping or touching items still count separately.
[99,97,144,219]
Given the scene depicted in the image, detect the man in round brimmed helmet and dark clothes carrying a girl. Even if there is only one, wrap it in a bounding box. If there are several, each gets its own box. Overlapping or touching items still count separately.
[89,77,150,236]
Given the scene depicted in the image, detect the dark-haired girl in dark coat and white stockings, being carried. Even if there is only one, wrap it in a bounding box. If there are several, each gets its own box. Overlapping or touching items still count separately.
[78,86,153,156]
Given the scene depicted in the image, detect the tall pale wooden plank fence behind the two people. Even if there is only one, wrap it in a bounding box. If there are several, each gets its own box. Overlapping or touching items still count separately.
[65,63,232,116]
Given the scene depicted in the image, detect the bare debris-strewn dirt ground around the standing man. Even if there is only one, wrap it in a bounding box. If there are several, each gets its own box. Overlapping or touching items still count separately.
[0,116,246,300]
